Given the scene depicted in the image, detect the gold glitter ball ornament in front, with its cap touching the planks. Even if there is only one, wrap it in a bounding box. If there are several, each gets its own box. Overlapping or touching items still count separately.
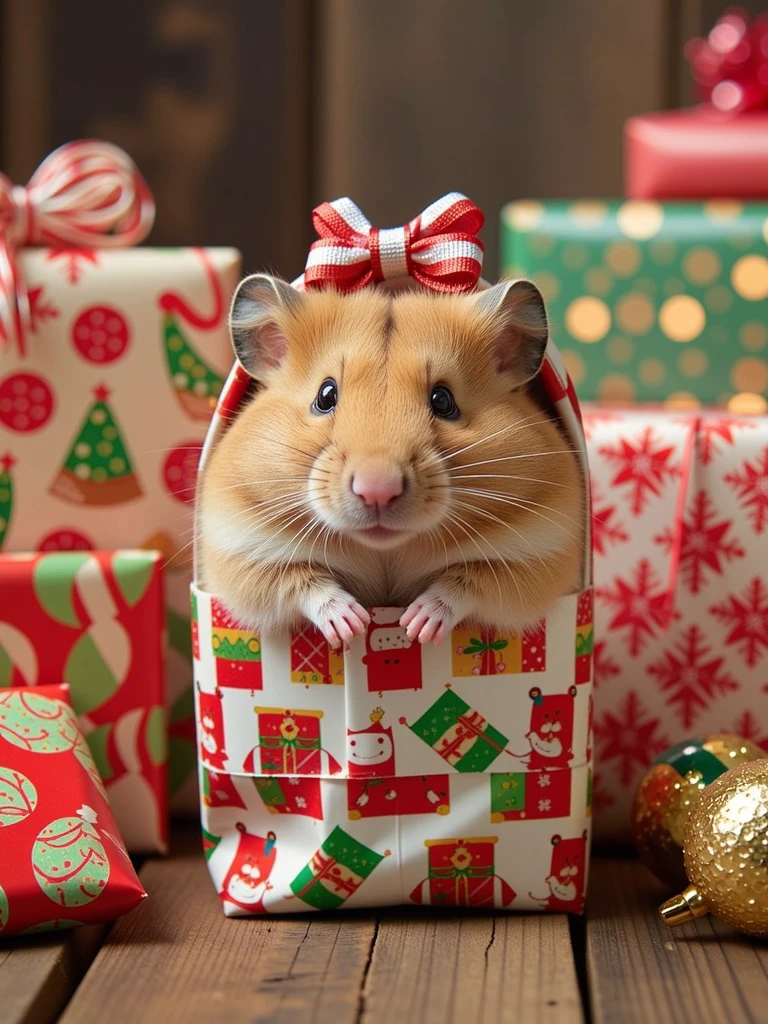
[659,759,768,937]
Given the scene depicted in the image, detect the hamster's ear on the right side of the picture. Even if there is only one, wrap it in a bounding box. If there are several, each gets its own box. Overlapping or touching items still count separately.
[475,281,549,387]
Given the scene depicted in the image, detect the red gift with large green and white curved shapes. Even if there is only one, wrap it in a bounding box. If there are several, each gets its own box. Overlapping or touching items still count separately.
[0,551,168,853]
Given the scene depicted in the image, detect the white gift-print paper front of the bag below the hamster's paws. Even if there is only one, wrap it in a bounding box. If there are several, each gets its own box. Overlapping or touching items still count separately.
[194,590,593,915]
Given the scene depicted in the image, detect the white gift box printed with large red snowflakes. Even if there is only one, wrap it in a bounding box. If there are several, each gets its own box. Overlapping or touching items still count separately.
[584,409,768,841]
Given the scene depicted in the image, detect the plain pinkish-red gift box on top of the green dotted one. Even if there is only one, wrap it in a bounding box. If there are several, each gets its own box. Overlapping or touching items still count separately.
[624,104,768,200]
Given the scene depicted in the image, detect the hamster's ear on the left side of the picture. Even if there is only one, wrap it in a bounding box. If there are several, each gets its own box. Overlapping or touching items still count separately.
[229,273,301,377]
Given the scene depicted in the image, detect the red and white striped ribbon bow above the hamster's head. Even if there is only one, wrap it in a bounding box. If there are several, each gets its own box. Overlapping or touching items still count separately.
[304,193,485,292]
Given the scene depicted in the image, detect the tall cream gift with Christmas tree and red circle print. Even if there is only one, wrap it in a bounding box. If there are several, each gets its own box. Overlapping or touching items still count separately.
[0,248,240,811]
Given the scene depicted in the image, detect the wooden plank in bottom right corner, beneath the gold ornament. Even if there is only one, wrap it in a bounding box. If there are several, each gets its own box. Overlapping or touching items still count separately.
[587,859,768,1024]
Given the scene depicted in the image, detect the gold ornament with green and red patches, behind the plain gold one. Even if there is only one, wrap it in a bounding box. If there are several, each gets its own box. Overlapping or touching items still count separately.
[631,733,768,889]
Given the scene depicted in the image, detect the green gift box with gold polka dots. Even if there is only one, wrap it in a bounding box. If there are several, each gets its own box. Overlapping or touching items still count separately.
[501,200,768,412]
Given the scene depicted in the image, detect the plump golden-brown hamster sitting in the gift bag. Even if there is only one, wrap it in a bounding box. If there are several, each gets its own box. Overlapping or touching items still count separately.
[199,274,585,646]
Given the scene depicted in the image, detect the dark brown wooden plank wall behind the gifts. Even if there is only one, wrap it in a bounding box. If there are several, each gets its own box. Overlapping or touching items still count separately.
[0,0,766,275]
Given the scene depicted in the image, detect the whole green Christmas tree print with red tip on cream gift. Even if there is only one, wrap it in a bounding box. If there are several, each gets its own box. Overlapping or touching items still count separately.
[50,385,141,505]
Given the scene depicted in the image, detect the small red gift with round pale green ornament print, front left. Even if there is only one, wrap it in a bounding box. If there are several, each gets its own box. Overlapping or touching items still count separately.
[0,685,146,938]
